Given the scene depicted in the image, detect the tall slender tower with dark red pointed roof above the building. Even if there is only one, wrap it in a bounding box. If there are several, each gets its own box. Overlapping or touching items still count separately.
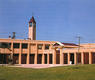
[28,16,36,40]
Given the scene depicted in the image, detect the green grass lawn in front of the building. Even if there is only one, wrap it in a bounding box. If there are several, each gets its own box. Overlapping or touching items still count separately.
[0,64,95,80]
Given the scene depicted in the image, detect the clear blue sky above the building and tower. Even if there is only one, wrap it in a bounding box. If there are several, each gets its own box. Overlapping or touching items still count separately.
[0,0,95,43]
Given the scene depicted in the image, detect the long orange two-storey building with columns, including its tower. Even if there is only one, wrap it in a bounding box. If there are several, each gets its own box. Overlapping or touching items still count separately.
[0,17,95,64]
